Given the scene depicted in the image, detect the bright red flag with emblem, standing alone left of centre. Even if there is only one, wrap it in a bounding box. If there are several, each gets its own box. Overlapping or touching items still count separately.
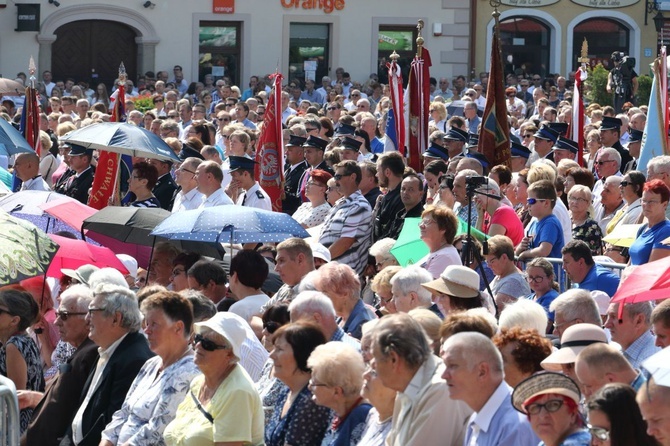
[254,73,284,212]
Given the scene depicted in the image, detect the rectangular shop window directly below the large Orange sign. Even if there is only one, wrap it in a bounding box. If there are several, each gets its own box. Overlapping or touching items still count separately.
[288,23,330,85]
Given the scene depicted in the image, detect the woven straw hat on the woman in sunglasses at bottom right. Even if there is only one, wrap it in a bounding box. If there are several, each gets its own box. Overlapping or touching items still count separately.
[512,372,581,413]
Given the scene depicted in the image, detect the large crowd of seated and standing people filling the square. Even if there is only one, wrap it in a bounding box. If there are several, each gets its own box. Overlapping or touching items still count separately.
[0,61,670,446]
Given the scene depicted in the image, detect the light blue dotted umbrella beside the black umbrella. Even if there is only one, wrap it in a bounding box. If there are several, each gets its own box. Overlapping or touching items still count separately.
[151,205,309,244]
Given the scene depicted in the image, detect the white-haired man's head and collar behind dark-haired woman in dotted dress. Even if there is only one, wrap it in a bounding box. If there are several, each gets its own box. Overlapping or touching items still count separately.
[288,291,361,350]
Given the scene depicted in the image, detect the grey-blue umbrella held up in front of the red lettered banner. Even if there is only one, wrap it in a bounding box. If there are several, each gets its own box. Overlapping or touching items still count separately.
[61,122,181,163]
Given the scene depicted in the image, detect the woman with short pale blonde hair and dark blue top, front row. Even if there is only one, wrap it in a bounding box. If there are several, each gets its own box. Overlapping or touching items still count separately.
[307,342,372,446]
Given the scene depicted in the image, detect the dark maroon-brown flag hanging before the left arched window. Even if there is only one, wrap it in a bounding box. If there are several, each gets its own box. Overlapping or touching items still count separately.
[477,24,511,167]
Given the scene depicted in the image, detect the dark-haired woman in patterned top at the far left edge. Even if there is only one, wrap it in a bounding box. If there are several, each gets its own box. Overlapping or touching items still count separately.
[0,286,44,433]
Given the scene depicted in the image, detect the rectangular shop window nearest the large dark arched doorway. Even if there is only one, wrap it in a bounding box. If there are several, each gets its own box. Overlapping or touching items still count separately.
[198,22,241,85]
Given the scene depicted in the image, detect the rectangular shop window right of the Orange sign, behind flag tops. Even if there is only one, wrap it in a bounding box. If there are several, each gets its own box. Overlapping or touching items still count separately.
[377,25,417,85]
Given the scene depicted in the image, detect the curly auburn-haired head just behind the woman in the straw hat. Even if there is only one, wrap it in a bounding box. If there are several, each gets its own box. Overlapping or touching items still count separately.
[493,327,552,387]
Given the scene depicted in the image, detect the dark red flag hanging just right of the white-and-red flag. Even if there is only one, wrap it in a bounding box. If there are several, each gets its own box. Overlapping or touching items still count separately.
[407,47,431,172]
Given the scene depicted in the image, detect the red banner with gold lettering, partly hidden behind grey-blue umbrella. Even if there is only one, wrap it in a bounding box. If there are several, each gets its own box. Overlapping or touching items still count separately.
[88,80,126,210]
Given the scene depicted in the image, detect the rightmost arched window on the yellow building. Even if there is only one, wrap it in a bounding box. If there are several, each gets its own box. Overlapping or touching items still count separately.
[570,19,632,69]
